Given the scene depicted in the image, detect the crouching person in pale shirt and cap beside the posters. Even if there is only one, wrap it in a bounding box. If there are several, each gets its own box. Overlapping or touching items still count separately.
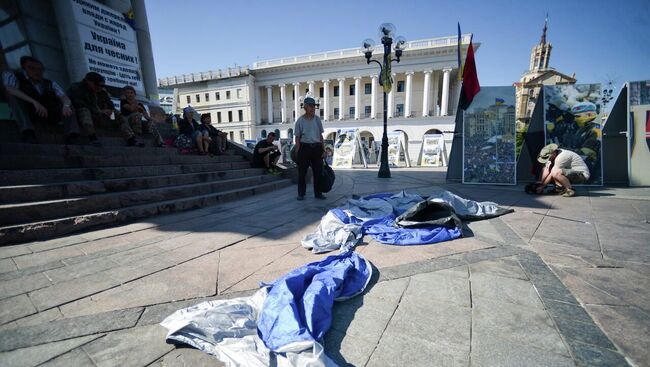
[536,144,590,197]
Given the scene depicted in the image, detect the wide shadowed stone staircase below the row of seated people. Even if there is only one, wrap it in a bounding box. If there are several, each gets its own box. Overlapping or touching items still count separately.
[0,121,291,245]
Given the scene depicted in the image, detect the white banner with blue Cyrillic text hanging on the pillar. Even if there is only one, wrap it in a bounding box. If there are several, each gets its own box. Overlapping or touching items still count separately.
[71,0,144,94]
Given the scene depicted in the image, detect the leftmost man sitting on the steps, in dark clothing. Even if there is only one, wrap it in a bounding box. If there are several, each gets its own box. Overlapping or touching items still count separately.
[2,56,79,144]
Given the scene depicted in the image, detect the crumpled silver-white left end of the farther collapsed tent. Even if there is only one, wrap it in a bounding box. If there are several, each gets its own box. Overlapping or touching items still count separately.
[300,210,363,254]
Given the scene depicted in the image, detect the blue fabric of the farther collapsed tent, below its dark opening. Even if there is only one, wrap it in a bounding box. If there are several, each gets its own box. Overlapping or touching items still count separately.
[367,218,462,246]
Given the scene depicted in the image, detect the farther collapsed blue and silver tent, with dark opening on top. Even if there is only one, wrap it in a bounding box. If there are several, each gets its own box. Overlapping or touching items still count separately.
[301,190,513,253]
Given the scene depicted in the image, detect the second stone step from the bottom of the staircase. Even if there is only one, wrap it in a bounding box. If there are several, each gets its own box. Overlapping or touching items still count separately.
[0,168,263,204]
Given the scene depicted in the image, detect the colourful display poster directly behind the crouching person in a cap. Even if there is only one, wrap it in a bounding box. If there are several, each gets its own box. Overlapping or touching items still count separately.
[544,84,603,186]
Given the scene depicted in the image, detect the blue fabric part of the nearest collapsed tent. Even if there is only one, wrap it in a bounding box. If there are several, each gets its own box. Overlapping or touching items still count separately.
[257,251,372,353]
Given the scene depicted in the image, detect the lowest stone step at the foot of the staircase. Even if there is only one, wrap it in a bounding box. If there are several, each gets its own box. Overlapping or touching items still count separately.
[0,175,279,226]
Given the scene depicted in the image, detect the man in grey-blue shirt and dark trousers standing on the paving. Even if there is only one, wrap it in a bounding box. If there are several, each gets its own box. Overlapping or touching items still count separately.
[294,97,325,200]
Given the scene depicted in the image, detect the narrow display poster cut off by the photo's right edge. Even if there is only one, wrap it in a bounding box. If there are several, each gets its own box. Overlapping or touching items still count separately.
[628,80,650,186]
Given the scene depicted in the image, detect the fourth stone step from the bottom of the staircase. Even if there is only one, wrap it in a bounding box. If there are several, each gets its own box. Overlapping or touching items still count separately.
[0,154,244,170]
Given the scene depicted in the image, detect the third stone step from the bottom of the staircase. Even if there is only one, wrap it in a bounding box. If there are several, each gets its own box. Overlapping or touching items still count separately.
[0,161,251,186]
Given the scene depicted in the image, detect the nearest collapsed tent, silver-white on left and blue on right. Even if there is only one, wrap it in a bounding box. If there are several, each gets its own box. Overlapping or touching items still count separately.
[161,251,372,366]
